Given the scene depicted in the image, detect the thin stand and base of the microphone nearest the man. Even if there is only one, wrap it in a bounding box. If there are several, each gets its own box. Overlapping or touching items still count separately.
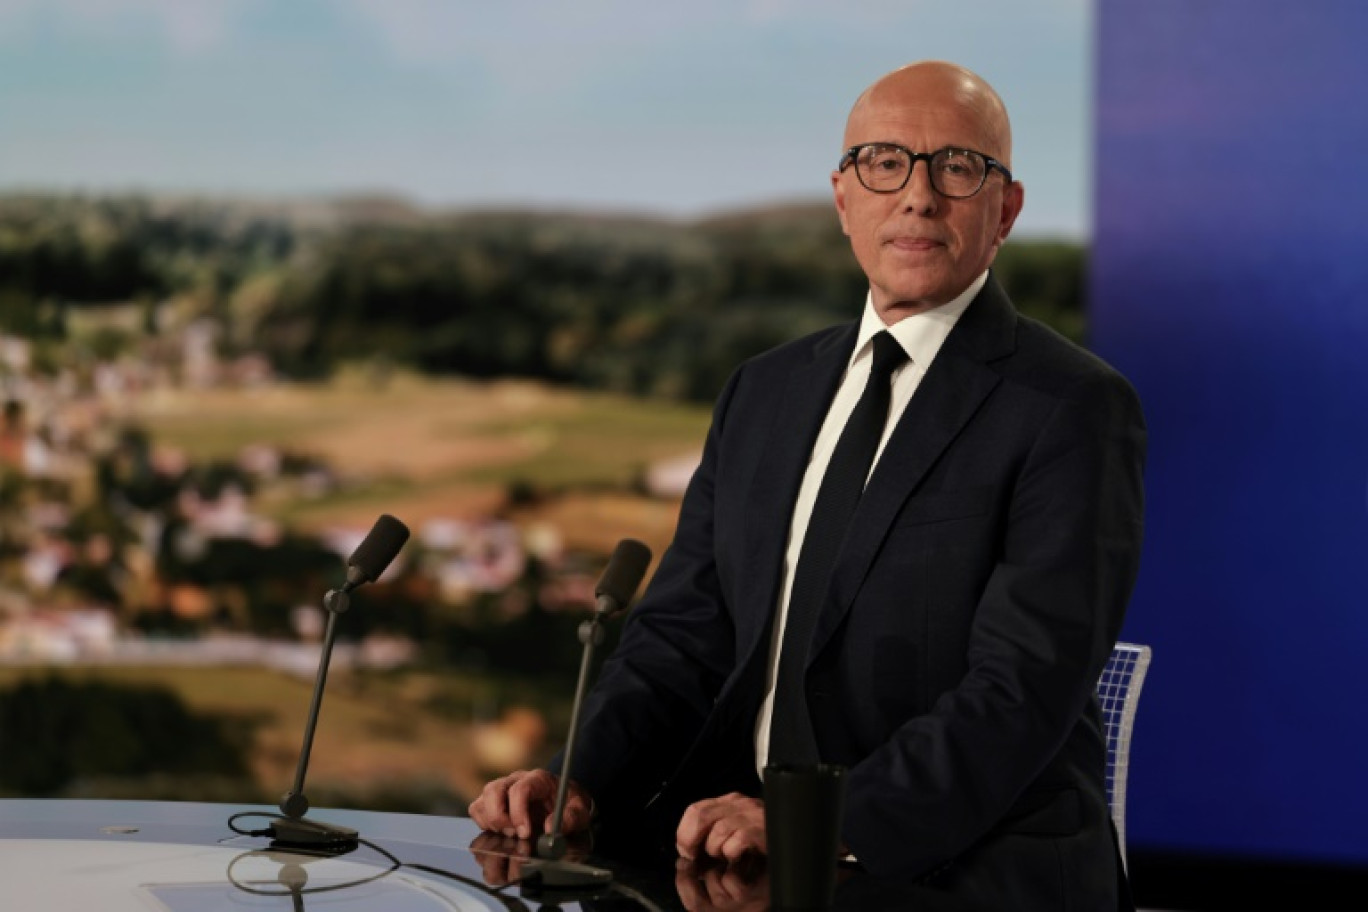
[523,603,613,902]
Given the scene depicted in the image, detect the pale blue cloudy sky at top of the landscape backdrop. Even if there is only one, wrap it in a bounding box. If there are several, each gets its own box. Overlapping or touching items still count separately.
[0,0,1094,238]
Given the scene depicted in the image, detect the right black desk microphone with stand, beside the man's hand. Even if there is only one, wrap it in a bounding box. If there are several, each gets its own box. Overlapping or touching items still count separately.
[523,539,651,896]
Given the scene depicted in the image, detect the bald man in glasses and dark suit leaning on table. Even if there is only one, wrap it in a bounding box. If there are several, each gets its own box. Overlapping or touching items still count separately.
[471,62,1145,909]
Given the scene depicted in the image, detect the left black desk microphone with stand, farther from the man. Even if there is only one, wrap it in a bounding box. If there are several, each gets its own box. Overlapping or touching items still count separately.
[272,513,409,848]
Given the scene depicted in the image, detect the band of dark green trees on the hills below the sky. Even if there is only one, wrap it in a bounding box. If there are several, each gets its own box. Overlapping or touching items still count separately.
[0,197,1085,402]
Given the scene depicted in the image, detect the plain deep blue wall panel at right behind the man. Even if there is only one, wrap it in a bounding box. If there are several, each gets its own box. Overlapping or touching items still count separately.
[1090,0,1368,863]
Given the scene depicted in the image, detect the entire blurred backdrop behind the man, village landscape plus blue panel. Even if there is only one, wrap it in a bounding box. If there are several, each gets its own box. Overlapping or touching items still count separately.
[0,0,1368,908]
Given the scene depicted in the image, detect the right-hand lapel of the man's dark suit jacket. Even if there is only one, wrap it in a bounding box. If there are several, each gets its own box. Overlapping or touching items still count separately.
[808,276,1016,662]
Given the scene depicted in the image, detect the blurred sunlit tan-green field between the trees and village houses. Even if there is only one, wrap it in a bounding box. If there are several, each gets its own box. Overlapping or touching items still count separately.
[129,369,709,547]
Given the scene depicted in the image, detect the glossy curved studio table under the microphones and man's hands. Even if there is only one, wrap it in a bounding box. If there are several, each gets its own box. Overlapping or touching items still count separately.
[0,799,1017,912]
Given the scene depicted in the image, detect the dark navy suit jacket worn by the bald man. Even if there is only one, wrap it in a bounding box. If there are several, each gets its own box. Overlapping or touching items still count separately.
[560,276,1145,909]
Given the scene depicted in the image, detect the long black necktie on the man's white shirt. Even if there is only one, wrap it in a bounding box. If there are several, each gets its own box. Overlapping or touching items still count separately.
[769,330,907,763]
